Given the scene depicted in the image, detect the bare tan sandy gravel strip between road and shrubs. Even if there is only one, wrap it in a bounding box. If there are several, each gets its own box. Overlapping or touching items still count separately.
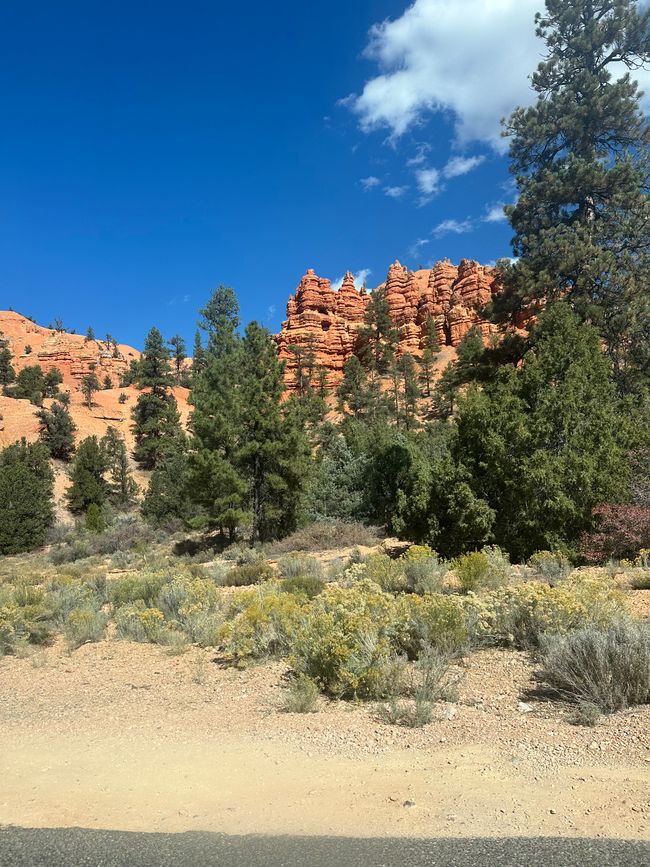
[0,641,650,839]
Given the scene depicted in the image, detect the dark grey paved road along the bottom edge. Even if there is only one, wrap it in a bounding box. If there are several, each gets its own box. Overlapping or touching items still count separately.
[0,828,650,867]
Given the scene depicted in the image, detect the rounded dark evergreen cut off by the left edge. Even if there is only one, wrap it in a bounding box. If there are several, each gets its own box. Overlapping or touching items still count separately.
[0,440,54,555]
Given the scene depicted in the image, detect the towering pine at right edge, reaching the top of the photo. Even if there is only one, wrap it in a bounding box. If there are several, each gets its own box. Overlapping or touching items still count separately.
[495,0,650,389]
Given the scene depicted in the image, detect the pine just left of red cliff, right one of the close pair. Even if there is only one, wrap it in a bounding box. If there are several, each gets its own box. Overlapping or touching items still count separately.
[235,322,307,542]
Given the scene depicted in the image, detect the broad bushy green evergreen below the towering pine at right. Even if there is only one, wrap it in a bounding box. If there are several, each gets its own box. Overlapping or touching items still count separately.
[455,302,628,558]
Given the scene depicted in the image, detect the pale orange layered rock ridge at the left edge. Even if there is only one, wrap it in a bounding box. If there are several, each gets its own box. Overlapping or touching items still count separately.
[0,310,140,390]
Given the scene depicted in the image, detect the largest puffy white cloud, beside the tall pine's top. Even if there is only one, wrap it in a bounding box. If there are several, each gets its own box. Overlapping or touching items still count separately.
[345,0,650,152]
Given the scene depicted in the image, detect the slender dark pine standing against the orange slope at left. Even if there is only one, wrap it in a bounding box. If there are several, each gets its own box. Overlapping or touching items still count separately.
[132,328,182,470]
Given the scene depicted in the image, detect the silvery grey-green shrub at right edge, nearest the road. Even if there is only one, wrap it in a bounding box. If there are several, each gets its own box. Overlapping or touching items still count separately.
[539,620,650,713]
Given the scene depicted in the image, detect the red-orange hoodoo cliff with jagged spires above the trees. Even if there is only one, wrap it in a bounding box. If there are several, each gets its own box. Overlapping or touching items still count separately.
[276,259,499,391]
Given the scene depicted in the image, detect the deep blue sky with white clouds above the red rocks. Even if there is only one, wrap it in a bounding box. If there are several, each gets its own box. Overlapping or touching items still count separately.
[0,0,644,346]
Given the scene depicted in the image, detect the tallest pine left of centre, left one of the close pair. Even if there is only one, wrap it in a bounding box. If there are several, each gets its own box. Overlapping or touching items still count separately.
[187,286,247,538]
